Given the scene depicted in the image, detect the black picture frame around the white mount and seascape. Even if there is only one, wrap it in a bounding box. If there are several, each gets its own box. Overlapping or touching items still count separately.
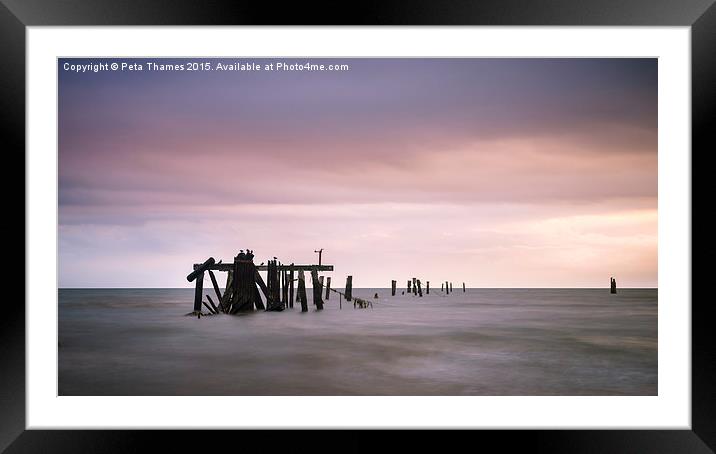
[0,0,716,453]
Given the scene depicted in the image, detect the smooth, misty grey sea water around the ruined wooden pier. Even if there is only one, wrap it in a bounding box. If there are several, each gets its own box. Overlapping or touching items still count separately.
[58,288,657,395]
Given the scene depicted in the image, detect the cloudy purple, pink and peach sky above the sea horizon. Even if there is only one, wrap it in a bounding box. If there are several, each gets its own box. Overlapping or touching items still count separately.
[58,58,658,287]
